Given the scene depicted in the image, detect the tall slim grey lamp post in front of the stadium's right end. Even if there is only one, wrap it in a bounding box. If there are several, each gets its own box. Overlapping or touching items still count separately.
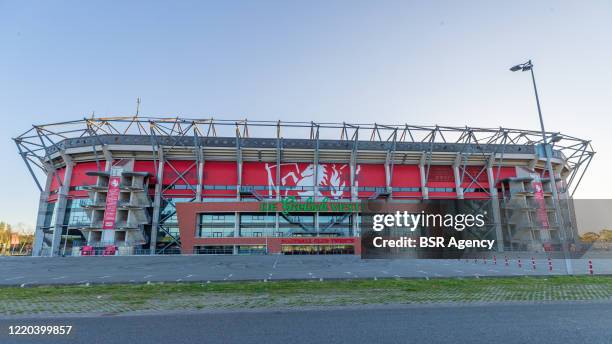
[510,60,573,275]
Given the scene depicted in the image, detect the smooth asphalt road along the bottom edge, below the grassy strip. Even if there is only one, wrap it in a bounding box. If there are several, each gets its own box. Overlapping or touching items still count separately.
[0,302,612,344]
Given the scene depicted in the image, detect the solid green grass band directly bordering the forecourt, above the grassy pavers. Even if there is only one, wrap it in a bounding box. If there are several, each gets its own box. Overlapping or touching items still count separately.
[0,276,612,301]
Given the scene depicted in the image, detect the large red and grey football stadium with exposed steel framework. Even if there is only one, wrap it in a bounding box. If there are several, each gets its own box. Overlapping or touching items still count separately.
[14,115,595,256]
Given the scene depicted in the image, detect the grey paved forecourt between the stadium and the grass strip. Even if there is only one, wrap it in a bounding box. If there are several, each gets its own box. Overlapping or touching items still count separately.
[0,255,612,286]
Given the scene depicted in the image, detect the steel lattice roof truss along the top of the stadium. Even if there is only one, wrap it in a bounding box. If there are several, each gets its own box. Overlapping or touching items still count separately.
[13,115,595,196]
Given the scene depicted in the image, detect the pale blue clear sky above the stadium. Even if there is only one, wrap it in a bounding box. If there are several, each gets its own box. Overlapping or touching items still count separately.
[0,0,612,230]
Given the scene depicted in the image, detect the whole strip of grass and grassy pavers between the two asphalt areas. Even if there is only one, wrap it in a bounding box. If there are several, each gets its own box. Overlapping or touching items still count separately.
[0,276,612,314]
